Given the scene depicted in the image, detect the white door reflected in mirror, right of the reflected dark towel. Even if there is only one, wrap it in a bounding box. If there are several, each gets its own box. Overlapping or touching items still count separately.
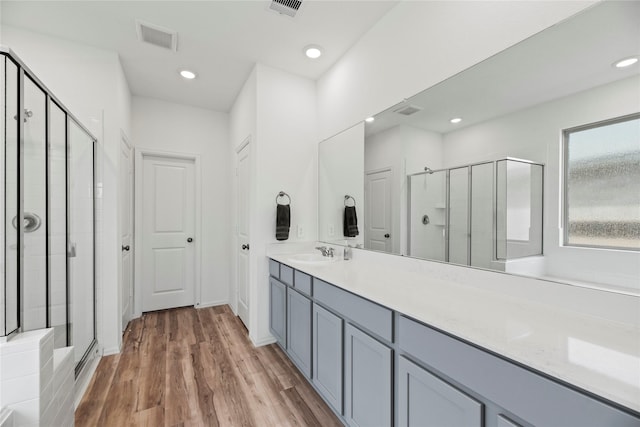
[364,169,393,252]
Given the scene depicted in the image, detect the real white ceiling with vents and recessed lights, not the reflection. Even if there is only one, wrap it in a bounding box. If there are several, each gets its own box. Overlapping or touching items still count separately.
[0,0,399,111]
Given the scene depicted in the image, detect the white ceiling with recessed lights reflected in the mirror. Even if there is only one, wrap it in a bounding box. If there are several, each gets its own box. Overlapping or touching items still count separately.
[366,1,640,136]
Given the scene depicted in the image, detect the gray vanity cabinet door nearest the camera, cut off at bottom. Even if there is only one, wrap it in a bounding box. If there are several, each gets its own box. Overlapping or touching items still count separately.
[398,357,482,427]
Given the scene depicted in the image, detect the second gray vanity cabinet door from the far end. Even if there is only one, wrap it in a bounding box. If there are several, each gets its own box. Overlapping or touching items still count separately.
[287,288,311,378]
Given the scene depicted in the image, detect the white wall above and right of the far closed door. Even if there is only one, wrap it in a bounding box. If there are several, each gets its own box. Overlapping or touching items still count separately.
[132,97,231,307]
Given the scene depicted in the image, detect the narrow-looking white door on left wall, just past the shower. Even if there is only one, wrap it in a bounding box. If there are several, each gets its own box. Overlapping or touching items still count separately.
[120,137,133,331]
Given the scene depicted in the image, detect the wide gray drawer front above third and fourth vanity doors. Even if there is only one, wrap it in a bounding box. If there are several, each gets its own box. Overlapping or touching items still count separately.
[313,278,393,341]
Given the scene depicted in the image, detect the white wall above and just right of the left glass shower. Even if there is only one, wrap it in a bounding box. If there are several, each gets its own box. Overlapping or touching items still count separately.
[1,25,131,354]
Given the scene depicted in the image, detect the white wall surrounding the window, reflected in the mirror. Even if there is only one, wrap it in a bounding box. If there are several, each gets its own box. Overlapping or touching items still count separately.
[444,77,640,290]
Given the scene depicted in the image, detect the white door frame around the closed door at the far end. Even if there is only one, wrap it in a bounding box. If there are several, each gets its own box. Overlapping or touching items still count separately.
[133,147,202,317]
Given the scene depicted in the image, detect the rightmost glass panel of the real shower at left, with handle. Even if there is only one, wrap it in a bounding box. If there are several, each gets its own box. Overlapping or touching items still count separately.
[67,119,95,362]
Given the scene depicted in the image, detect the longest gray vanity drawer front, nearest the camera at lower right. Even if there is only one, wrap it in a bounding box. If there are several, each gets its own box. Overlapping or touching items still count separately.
[398,316,638,427]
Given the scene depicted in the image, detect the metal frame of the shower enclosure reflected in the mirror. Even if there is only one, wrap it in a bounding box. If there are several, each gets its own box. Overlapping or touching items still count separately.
[406,157,546,266]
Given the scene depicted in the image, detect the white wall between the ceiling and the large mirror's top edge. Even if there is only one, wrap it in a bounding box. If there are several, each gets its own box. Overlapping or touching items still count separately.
[318,1,596,140]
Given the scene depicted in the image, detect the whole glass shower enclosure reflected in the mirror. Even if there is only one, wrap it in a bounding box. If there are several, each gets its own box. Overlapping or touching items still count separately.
[407,158,543,271]
